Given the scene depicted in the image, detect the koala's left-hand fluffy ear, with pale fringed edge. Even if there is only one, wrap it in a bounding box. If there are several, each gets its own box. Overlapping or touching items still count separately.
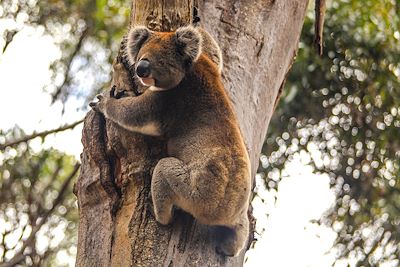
[126,26,152,65]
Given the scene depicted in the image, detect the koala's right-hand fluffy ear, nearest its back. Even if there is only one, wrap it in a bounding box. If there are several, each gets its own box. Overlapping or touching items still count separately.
[175,26,202,62]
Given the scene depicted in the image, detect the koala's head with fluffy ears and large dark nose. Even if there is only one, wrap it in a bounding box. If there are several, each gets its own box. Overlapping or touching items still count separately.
[127,26,202,90]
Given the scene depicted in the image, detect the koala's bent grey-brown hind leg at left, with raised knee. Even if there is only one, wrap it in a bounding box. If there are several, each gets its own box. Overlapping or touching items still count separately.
[151,157,191,225]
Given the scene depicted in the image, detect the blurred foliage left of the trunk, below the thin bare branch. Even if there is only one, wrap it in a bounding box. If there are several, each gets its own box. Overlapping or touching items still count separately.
[0,130,79,266]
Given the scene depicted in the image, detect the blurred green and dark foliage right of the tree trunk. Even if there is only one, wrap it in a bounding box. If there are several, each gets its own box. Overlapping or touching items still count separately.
[260,0,400,266]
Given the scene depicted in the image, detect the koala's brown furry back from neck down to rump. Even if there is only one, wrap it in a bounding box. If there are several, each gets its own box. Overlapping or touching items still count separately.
[159,56,250,224]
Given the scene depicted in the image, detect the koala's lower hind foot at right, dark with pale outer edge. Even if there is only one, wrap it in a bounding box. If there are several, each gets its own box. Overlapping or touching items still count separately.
[216,211,249,256]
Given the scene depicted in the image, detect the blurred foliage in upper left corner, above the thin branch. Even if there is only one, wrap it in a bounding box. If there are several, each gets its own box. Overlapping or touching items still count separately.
[0,0,130,102]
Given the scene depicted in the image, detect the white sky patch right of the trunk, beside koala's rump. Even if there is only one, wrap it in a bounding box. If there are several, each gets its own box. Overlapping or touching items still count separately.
[245,162,336,267]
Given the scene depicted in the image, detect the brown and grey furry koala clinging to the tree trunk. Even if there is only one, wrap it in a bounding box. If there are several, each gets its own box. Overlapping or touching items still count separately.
[91,26,251,256]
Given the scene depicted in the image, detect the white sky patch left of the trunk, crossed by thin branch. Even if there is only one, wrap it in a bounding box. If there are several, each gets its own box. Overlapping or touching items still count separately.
[0,23,85,156]
